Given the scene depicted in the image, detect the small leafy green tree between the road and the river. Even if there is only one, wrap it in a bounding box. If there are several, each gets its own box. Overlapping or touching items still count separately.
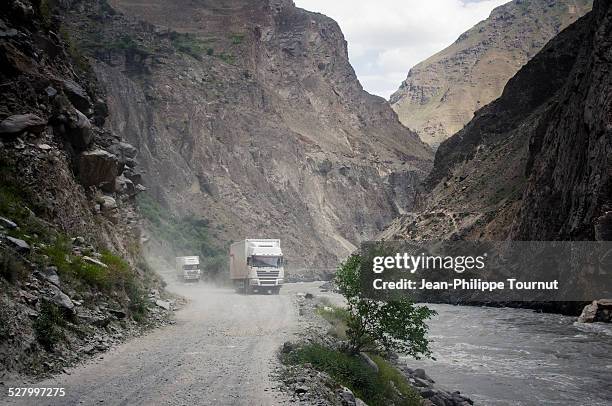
[336,254,436,359]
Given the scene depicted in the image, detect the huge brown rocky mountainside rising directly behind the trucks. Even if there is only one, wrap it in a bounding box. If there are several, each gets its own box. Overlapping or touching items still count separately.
[61,0,432,268]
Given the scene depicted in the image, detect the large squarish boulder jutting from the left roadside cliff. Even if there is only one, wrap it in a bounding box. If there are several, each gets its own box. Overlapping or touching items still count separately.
[78,149,118,192]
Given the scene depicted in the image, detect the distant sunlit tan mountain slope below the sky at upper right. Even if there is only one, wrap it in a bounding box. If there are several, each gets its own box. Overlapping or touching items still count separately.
[390,0,592,147]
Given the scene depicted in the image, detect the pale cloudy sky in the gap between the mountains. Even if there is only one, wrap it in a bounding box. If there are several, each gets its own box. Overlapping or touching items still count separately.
[294,0,508,99]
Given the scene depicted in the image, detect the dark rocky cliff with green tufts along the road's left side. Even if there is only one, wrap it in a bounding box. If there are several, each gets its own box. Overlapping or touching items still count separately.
[0,0,172,380]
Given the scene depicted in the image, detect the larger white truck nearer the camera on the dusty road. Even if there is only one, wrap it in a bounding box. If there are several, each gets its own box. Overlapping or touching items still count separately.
[229,239,285,295]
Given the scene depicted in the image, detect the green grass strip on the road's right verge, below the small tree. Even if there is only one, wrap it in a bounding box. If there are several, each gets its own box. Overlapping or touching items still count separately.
[283,344,421,406]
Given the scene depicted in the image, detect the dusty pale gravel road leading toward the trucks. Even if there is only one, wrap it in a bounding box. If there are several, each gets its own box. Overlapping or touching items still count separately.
[2,284,308,406]
